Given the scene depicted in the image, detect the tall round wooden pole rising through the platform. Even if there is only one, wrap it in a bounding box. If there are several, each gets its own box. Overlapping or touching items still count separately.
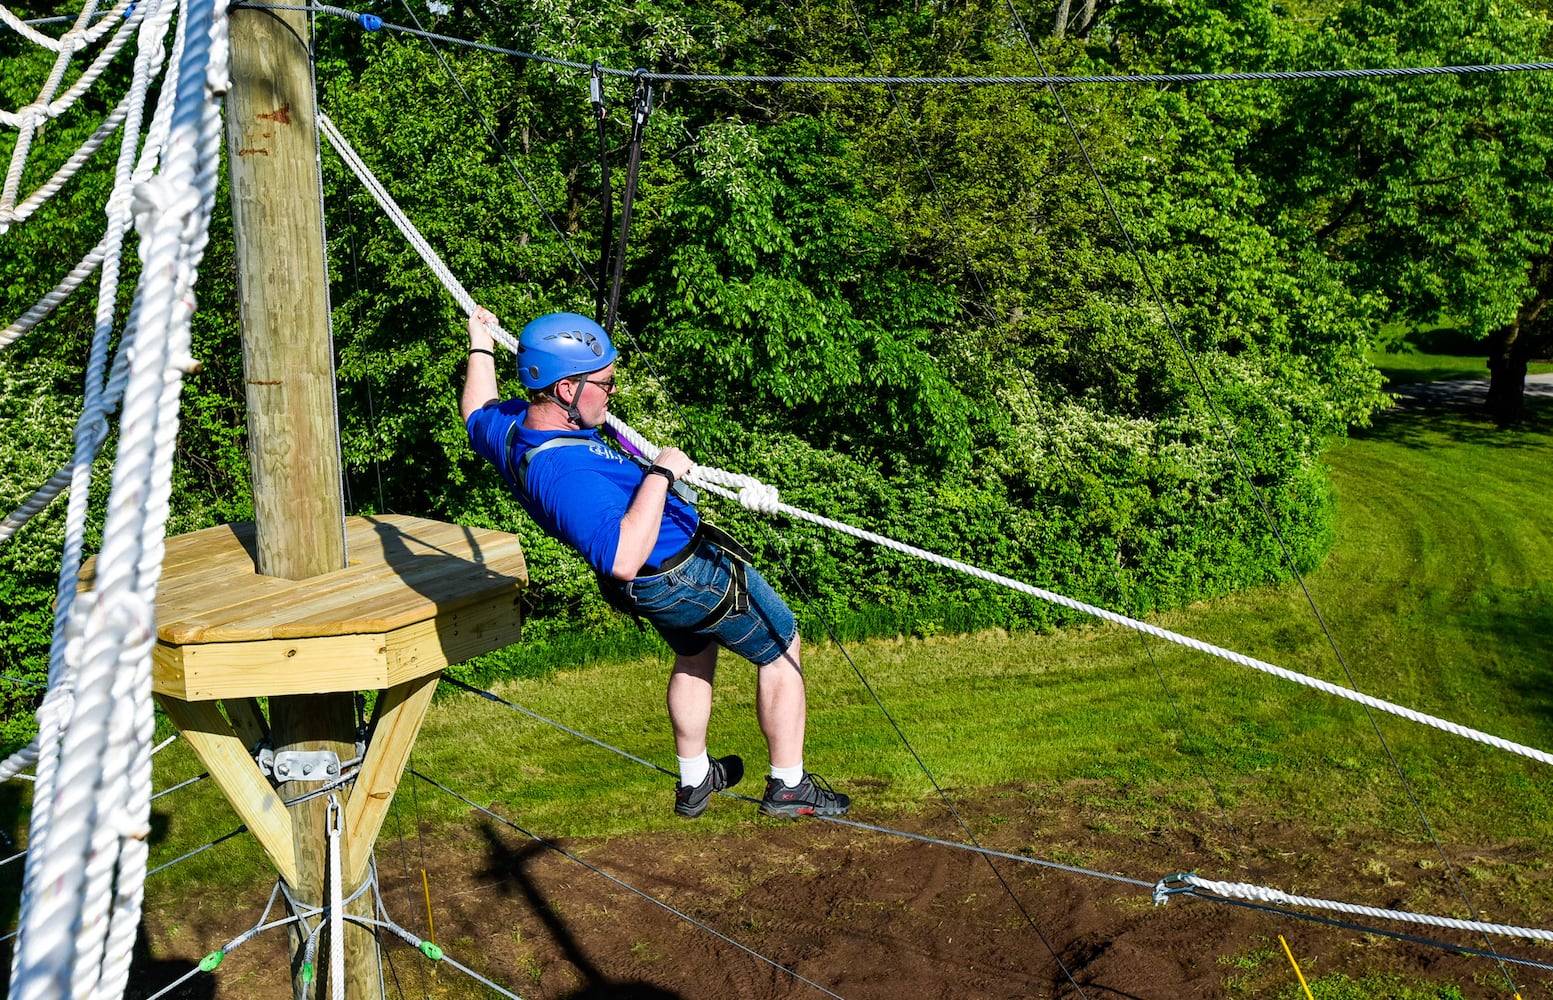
[227,9,379,1000]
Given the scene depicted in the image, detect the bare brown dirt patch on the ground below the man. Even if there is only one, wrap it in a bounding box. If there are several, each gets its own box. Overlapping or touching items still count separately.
[129,787,1553,1000]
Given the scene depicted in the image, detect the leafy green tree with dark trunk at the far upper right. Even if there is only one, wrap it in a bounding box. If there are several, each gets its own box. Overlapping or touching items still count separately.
[1263,0,1553,419]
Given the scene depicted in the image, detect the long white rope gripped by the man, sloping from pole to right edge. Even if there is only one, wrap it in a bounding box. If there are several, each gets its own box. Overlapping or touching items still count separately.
[318,95,1553,764]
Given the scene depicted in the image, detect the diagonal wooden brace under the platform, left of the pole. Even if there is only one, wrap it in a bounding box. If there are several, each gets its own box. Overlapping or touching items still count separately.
[157,696,297,885]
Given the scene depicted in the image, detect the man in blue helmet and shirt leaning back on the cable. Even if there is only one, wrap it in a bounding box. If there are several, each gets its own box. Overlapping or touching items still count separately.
[461,309,851,817]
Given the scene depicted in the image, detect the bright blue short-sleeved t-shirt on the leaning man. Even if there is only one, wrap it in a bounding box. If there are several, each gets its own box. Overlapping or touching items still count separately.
[464,399,699,576]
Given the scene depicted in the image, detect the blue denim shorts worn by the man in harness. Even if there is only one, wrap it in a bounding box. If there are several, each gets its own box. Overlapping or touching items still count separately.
[624,542,798,666]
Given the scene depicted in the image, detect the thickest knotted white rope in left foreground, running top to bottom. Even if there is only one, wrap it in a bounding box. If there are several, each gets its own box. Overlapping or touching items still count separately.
[12,2,227,1000]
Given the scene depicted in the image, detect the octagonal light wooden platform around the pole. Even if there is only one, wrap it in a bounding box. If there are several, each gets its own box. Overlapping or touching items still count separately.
[82,514,528,702]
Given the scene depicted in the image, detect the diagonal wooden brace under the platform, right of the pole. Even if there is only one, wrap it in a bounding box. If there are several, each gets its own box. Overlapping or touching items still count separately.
[345,671,441,885]
